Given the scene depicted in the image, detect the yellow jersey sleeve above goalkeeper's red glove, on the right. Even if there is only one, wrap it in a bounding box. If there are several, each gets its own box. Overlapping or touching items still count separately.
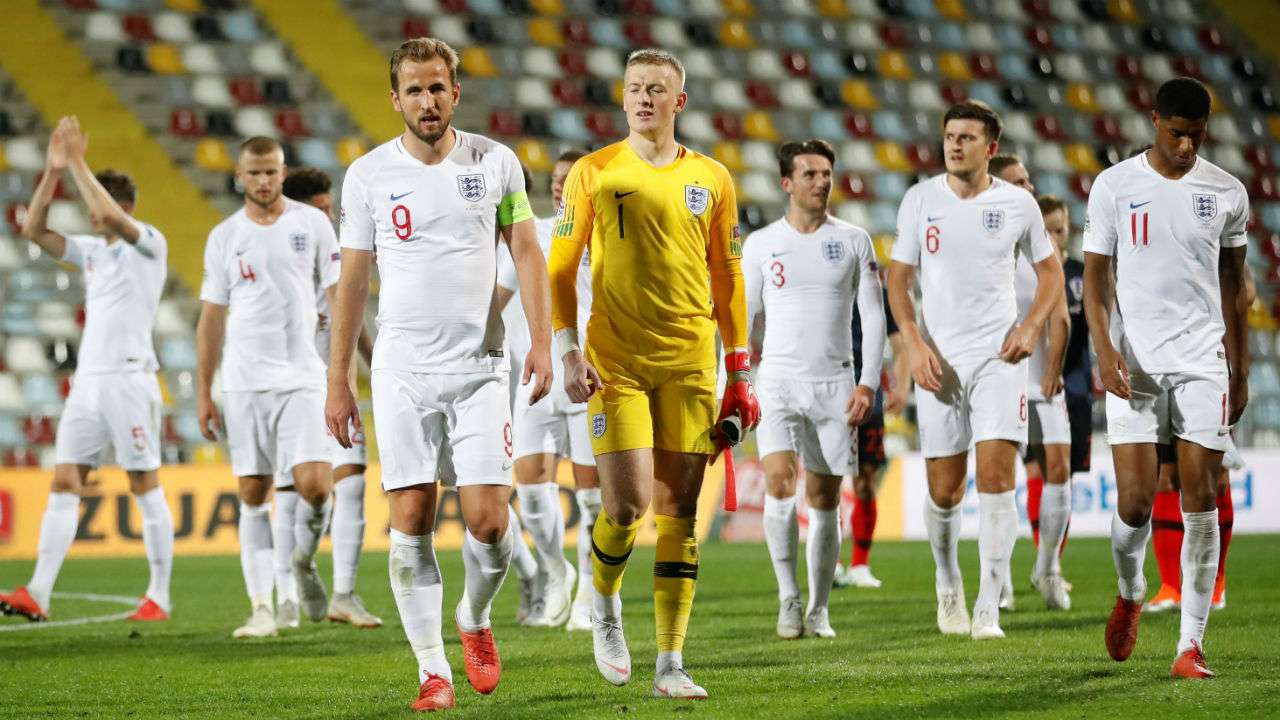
[707,165,748,352]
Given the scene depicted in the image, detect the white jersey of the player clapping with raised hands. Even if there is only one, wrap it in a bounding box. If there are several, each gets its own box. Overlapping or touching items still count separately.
[61,220,169,375]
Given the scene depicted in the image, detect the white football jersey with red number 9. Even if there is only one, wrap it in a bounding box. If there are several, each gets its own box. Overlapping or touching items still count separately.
[340,129,525,373]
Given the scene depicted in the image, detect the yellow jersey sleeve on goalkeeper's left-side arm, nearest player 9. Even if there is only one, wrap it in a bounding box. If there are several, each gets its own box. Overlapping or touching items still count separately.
[548,159,595,332]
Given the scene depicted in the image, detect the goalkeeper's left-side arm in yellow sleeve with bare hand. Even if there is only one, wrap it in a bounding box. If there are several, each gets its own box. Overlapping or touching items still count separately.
[547,160,600,402]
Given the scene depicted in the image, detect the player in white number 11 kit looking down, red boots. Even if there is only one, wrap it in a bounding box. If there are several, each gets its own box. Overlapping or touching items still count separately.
[1084,77,1249,678]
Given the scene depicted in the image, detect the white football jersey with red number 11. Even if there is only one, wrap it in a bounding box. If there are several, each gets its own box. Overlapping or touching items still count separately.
[1084,152,1249,373]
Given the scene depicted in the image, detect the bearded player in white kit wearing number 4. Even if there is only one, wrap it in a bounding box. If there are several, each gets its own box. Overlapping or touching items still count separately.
[196,137,338,638]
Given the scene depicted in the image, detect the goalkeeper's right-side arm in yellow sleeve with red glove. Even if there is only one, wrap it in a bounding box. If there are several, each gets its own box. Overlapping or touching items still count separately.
[707,170,760,430]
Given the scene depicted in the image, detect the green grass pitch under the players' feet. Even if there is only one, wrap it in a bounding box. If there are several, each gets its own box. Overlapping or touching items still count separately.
[0,536,1280,720]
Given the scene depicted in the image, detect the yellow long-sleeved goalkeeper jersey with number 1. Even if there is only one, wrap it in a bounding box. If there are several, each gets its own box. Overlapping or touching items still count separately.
[549,140,748,369]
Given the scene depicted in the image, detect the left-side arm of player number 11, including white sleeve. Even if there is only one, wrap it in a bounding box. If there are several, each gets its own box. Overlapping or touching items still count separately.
[1084,182,1130,400]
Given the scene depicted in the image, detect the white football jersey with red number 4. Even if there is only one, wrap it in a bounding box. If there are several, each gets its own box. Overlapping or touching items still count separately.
[200,199,339,391]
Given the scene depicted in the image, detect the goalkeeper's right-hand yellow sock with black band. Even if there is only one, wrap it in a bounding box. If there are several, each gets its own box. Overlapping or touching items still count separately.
[653,515,698,653]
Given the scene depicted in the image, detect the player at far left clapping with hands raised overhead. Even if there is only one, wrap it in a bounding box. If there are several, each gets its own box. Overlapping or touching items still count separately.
[0,117,173,620]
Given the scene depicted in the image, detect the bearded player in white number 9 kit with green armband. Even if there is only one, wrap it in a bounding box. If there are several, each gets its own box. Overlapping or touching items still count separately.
[325,37,550,710]
